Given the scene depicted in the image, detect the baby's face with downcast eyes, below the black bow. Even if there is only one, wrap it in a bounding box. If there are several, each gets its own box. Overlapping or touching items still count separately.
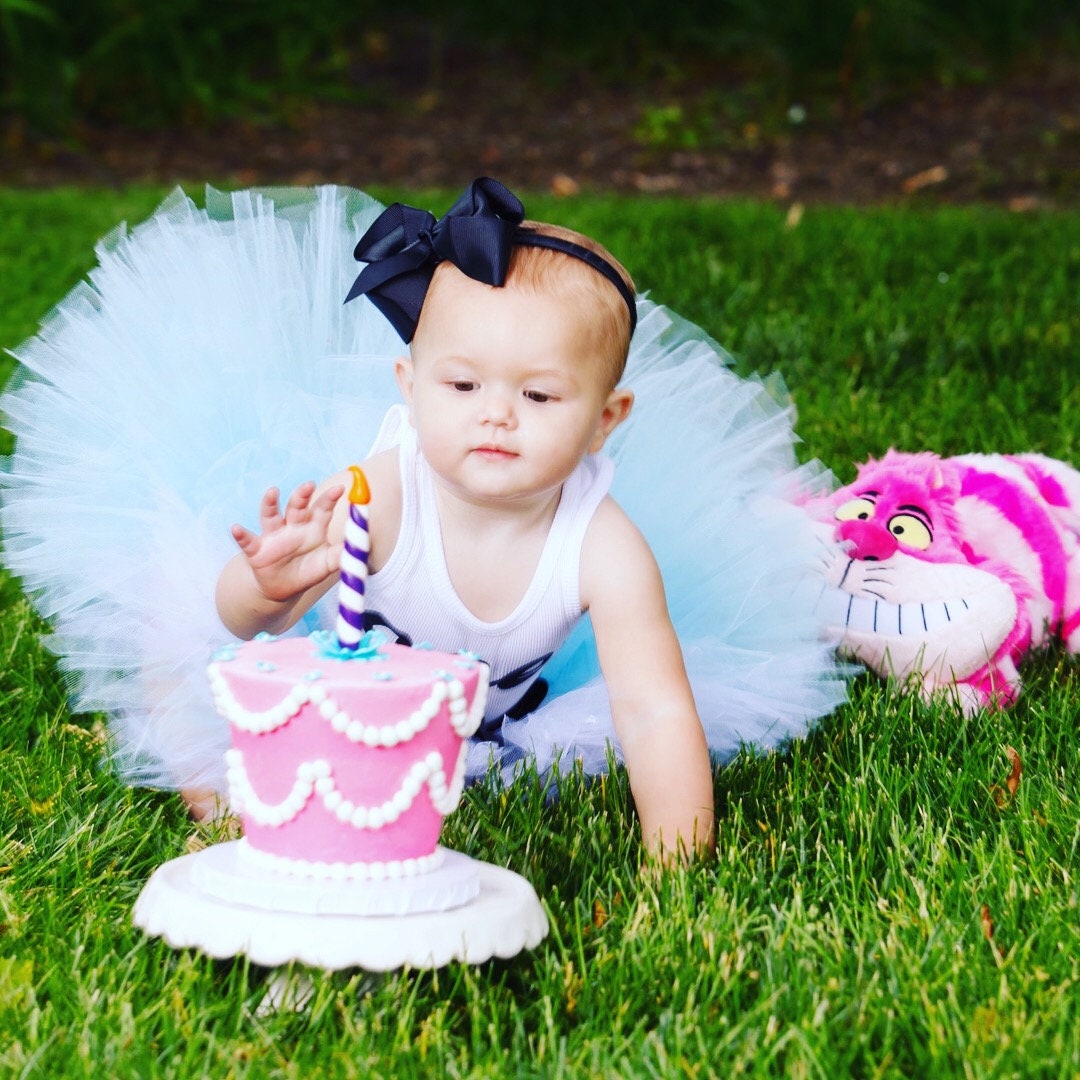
[399,270,632,504]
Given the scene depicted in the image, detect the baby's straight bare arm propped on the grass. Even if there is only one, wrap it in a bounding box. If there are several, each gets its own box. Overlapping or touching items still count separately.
[581,499,714,860]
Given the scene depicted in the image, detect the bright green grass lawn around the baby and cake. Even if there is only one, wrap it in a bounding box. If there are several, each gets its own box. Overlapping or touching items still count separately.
[0,190,1080,1078]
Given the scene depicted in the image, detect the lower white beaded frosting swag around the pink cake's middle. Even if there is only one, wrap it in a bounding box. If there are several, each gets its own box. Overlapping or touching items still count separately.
[225,747,465,829]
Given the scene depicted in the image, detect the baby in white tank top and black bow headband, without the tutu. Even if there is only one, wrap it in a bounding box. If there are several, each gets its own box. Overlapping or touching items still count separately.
[217,179,714,859]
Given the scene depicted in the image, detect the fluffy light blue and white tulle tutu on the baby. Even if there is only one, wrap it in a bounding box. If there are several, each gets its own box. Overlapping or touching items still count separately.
[0,187,845,789]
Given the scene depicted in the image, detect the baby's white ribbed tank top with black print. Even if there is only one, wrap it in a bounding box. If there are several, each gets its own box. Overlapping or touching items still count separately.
[349,408,615,720]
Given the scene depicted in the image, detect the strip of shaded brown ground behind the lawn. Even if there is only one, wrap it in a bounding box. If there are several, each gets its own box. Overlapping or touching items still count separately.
[0,49,1080,210]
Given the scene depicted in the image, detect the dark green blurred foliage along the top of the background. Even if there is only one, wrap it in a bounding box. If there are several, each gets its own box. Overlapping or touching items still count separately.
[0,0,1080,132]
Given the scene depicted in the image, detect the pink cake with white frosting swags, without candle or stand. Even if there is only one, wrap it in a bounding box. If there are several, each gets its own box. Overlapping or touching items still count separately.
[210,634,488,880]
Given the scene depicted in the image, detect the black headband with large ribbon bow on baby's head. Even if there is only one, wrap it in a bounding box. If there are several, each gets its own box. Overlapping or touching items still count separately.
[345,176,637,341]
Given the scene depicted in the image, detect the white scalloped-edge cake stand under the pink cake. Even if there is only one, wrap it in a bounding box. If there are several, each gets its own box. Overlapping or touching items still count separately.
[133,841,548,971]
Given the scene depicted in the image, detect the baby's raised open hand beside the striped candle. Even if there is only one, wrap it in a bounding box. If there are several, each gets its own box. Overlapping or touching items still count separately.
[232,481,345,602]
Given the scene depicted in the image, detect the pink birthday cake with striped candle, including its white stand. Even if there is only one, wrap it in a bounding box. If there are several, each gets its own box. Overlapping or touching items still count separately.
[133,467,548,971]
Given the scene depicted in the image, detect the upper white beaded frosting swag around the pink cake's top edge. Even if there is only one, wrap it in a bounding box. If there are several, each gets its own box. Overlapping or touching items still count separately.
[210,663,486,746]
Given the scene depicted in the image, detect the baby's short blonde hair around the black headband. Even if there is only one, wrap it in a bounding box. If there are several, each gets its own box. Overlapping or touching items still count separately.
[418,221,636,389]
